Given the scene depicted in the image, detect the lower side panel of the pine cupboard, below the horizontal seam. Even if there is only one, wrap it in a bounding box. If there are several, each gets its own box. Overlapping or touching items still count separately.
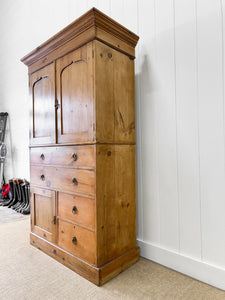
[96,145,136,267]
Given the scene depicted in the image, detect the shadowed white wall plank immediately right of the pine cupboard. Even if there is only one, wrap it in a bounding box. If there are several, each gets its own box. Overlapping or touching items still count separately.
[136,0,160,244]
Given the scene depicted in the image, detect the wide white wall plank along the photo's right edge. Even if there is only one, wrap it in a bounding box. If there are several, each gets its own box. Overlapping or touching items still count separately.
[197,0,225,266]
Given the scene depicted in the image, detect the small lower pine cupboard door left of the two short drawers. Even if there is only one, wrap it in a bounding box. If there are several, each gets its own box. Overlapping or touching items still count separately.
[31,188,56,243]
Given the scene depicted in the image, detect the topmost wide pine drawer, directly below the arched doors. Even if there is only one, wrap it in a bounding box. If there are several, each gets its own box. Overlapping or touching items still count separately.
[30,145,95,169]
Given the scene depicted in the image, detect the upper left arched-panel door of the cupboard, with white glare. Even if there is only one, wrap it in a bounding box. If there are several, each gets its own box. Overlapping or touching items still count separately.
[30,63,56,144]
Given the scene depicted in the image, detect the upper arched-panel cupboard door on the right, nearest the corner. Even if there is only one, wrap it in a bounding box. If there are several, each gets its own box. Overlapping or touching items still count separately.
[56,43,94,143]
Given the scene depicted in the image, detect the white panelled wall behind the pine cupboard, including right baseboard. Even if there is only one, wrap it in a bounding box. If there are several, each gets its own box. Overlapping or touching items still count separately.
[0,0,225,289]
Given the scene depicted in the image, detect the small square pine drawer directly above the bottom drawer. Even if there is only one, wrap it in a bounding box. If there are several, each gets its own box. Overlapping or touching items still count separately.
[58,192,95,230]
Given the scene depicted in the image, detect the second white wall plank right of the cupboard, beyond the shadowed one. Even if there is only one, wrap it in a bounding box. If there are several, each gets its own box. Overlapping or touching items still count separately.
[155,0,179,251]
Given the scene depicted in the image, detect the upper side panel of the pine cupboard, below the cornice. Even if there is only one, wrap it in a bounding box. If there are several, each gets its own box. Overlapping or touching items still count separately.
[94,41,135,144]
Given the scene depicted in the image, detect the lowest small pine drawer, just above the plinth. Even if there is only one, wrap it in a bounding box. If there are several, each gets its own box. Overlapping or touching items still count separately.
[58,219,96,264]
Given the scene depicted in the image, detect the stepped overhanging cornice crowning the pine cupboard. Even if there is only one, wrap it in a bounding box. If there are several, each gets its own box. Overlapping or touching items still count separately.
[21,8,139,66]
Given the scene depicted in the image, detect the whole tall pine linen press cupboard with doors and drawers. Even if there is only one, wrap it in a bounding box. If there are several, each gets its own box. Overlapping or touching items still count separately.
[21,8,139,285]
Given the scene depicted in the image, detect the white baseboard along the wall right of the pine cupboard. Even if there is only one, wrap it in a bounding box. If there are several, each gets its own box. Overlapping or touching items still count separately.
[137,240,225,290]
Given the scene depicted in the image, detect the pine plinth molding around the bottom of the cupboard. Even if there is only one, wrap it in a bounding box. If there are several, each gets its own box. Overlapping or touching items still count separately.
[30,233,139,286]
